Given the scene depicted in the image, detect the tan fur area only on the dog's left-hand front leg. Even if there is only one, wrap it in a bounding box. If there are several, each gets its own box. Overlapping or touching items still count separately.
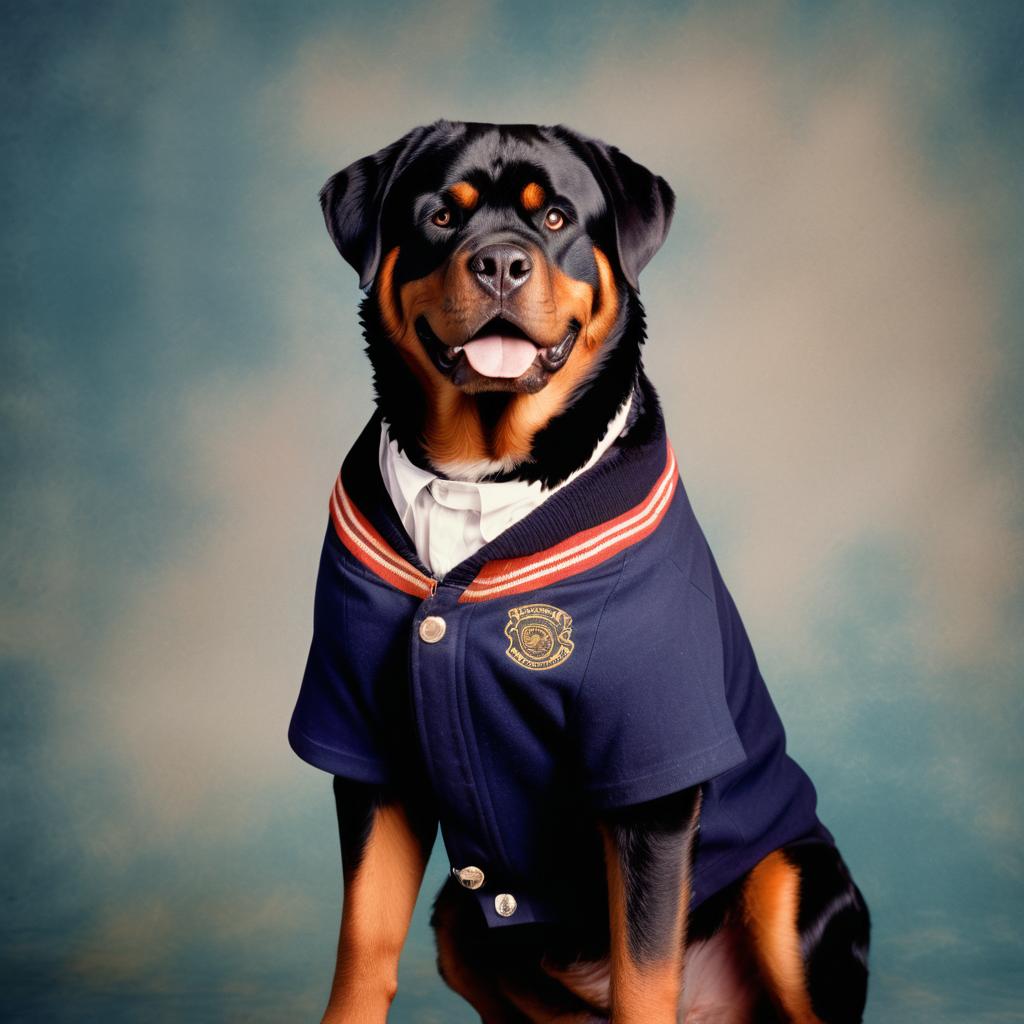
[325,804,426,1020]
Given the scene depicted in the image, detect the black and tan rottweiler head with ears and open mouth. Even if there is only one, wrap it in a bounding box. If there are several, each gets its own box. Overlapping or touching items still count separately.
[321,121,674,479]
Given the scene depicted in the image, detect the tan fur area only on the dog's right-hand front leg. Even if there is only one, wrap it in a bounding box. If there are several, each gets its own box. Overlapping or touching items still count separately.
[601,825,689,1024]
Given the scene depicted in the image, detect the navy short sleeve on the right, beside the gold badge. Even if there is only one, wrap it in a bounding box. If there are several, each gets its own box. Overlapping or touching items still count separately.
[573,559,745,809]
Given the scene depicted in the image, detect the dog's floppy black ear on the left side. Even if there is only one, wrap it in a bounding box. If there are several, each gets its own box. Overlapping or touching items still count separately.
[319,125,435,290]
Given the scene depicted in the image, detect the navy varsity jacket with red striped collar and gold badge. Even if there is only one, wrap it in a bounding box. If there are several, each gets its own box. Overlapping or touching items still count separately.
[289,381,833,927]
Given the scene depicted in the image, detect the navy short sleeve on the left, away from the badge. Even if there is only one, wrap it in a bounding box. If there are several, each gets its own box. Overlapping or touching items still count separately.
[288,524,400,783]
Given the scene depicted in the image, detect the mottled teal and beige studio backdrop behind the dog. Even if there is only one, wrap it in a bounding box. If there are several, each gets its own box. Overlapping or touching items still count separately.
[0,0,1024,1024]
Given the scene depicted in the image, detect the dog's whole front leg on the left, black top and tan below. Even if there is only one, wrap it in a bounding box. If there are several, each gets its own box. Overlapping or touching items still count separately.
[323,777,437,1024]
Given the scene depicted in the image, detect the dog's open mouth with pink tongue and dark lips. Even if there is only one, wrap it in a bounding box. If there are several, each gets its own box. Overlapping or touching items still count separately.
[416,316,580,384]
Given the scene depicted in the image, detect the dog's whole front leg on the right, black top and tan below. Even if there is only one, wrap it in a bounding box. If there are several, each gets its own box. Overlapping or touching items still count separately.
[599,786,700,1024]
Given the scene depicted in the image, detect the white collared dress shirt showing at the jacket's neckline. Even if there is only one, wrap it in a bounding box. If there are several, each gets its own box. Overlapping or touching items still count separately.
[380,395,633,578]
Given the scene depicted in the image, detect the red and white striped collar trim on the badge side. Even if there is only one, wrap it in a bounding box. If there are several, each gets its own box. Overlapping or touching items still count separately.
[459,443,679,603]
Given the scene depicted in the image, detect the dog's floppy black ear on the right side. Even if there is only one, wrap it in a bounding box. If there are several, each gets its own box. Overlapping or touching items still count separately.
[555,125,676,291]
